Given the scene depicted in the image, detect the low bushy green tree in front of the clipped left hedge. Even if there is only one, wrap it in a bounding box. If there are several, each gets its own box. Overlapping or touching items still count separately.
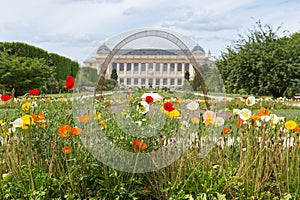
[0,53,54,96]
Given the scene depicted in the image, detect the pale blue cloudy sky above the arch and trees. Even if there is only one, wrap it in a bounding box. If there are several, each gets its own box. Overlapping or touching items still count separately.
[0,0,300,63]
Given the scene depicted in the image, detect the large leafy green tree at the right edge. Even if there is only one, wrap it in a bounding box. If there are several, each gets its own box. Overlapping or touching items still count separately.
[216,22,300,97]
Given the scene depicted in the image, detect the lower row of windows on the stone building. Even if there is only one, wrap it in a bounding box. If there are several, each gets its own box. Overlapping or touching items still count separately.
[119,78,182,86]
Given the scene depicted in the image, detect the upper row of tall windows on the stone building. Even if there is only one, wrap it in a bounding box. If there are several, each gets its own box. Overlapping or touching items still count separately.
[112,63,190,72]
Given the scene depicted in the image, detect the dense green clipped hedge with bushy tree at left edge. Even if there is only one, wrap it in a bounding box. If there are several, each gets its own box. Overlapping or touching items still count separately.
[0,42,79,95]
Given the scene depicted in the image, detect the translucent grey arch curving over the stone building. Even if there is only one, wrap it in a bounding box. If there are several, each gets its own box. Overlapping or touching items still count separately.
[95,30,210,109]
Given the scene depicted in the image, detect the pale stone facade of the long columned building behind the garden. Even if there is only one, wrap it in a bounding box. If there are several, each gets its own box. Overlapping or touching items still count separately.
[83,44,214,87]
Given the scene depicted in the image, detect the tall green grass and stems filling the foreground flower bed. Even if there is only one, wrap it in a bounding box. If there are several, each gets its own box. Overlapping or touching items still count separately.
[0,93,300,199]
